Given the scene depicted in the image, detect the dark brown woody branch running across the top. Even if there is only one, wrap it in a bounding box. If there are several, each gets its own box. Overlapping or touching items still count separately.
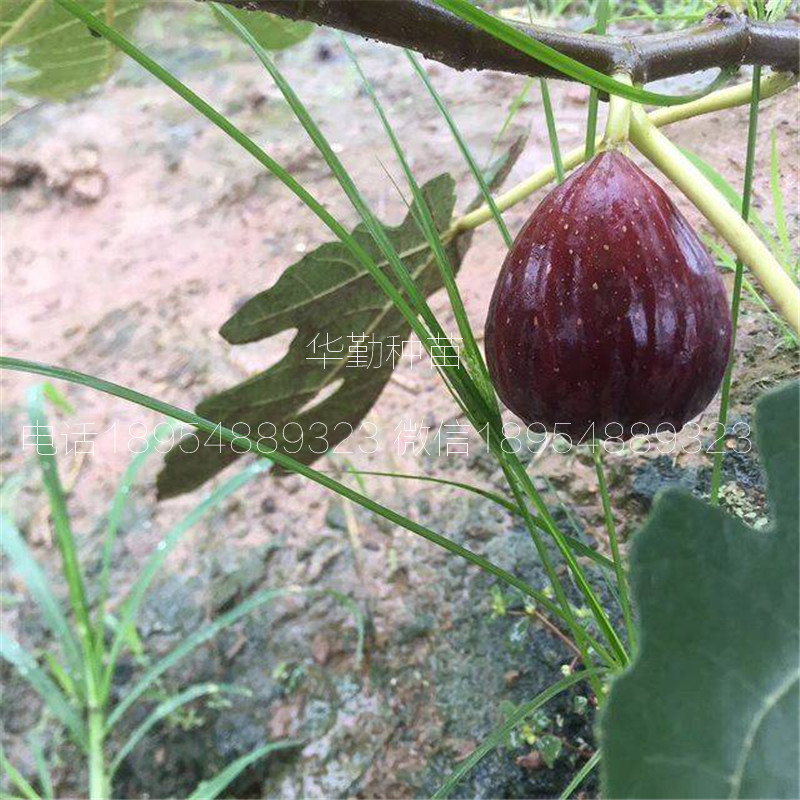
[214,0,800,83]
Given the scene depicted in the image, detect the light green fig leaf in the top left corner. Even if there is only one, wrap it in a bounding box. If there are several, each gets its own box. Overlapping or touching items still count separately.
[0,0,147,100]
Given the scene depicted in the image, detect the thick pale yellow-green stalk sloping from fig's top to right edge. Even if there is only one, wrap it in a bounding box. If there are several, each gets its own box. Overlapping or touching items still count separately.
[630,105,800,333]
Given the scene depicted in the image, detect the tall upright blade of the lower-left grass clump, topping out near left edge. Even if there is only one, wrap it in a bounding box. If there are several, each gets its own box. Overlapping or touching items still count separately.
[27,386,94,656]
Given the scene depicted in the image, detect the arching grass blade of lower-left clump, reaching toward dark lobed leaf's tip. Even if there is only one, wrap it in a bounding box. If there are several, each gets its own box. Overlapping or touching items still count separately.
[102,459,271,697]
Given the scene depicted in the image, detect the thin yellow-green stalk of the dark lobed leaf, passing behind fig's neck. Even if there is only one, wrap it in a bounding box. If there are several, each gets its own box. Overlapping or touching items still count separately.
[444,72,798,241]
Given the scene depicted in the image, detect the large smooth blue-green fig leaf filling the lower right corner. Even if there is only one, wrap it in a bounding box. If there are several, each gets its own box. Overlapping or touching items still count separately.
[601,383,800,798]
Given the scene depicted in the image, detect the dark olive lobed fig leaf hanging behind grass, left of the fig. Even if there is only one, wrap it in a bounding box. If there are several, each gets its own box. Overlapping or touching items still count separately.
[158,140,523,498]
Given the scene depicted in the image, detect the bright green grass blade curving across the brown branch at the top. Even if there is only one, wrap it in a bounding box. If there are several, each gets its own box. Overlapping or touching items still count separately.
[434,0,733,106]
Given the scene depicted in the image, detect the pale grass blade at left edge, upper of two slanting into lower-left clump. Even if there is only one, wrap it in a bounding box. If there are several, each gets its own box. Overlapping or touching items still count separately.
[0,514,82,675]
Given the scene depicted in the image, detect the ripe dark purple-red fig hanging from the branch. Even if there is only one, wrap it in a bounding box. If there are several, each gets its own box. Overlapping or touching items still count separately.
[486,151,731,441]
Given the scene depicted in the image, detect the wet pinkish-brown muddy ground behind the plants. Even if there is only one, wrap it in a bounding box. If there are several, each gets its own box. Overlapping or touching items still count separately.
[0,4,799,798]
